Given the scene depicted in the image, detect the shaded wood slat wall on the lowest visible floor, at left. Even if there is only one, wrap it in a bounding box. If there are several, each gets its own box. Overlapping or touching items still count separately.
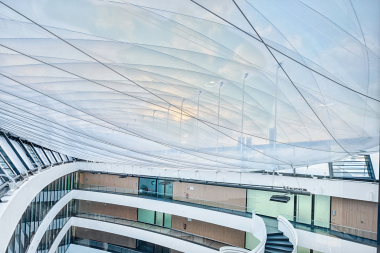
[75,227,136,249]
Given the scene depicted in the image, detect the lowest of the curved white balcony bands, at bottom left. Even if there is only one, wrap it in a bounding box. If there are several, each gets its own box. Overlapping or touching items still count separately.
[49,217,218,253]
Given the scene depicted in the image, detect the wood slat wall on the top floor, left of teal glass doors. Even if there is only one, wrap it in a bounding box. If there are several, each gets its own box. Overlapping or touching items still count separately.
[79,172,139,193]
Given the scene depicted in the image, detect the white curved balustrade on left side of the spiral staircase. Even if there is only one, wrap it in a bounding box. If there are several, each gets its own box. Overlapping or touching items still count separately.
[219,211,267,253]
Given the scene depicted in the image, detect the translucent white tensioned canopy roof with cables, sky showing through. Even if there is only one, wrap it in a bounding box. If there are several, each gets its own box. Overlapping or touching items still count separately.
[0,0,380,170]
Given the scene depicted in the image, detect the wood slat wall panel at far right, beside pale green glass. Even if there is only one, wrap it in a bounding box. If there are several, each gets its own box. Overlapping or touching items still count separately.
[331,197,377,233]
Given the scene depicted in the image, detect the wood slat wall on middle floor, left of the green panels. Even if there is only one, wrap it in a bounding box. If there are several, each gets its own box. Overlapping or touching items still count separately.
[78,200,137,220]
